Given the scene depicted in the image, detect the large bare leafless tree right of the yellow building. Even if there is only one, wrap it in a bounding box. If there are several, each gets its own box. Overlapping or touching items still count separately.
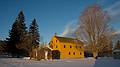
[76,5,111,56]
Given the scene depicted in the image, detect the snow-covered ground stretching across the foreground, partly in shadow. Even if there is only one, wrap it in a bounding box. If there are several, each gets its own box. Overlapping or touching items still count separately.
[0,58,120,67]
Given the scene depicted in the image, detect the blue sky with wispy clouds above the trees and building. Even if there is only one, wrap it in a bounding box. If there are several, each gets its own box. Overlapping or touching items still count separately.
[0,0,120,43]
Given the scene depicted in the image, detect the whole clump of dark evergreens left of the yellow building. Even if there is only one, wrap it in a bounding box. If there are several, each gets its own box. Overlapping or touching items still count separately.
[0,11,40,57]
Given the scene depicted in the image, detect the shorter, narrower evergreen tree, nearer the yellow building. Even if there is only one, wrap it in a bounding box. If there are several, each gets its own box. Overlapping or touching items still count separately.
[29,19,40,48]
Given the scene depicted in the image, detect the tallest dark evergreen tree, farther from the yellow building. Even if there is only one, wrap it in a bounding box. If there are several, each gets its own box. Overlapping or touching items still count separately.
[8,11,27,56]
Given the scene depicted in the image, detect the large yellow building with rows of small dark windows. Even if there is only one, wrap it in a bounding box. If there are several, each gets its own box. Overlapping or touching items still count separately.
[49,34,84,59]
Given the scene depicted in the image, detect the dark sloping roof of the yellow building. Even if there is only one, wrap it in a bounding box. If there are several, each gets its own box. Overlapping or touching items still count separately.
[55,36,83,44]
